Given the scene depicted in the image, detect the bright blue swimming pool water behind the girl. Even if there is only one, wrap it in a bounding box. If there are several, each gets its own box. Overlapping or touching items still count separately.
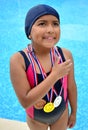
[0,0,88,130]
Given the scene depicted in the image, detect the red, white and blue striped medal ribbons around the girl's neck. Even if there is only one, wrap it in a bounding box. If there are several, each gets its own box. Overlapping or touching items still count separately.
[28,45,63,102]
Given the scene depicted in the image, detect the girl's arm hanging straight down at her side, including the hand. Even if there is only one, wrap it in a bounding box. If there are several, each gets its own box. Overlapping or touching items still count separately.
[63,49,77,128]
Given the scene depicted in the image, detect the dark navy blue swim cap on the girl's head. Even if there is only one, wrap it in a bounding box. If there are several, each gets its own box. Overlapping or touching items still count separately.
[25,4,60,39]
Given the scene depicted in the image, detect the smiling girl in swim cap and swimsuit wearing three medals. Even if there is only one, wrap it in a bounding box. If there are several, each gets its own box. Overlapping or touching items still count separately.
[10,5,77,130]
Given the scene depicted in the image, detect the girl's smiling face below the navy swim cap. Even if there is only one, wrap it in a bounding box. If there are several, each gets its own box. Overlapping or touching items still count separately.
[29,15,60,48]
